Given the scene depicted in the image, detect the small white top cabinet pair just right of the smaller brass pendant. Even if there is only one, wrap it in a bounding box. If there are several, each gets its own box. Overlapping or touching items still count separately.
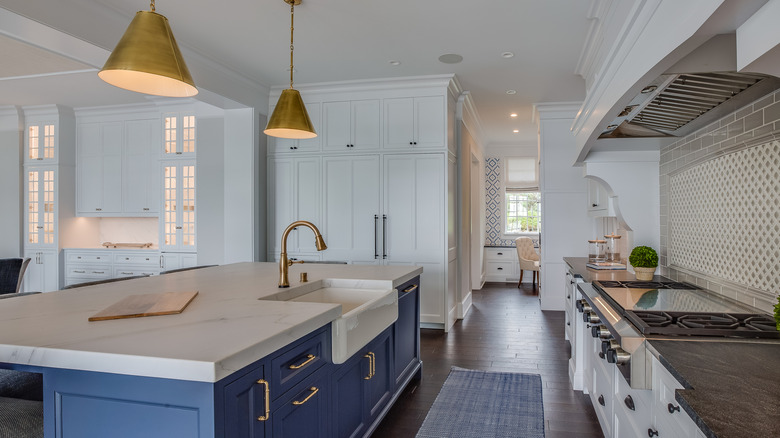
[322,99,381,151]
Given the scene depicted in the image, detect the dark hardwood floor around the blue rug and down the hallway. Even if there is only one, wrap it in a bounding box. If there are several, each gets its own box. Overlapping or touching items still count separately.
[373,283,603,438]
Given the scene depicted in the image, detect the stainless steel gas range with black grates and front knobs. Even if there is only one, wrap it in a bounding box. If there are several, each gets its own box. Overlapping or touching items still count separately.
[576,281,780,389]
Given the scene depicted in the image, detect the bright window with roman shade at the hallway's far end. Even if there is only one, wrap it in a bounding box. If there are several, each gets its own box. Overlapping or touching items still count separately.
[504,157,542,234]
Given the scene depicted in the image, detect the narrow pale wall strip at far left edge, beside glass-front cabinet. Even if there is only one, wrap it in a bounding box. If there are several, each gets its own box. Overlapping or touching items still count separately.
[0,107,23,258]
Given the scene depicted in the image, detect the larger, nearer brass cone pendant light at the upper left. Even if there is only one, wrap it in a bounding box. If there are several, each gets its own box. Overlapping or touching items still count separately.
[98,0,198,97]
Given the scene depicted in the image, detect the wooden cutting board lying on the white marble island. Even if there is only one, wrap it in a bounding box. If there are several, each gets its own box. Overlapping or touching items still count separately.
[89,291,198,321]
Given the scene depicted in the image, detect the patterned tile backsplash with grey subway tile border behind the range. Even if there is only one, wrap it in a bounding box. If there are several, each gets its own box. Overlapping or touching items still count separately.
[659,88,780,312]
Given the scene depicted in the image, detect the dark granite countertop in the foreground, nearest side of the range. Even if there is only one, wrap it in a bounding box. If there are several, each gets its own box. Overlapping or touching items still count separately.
[648,340,780,438]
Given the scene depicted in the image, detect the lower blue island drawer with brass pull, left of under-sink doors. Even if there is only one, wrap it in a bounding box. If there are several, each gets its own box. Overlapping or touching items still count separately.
[271,367,330,438]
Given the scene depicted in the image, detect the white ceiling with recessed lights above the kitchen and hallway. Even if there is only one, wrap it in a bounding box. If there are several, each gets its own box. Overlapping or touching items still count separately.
[0,0,591,146]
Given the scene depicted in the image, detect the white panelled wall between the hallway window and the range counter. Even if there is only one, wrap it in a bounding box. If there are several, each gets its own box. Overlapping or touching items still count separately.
[536,103,591,310]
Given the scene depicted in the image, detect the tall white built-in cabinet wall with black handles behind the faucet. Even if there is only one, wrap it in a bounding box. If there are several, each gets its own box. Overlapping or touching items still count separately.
[268,75,457,329]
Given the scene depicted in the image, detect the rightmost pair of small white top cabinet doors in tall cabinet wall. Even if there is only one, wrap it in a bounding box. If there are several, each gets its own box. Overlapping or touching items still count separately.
[384,96,446,149]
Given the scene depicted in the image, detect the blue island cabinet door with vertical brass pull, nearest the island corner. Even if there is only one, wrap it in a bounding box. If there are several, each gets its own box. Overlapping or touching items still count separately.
[224,365,271,438]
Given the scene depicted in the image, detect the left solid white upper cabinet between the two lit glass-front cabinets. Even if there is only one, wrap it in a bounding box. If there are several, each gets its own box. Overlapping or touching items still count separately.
[77,122,124,216]
